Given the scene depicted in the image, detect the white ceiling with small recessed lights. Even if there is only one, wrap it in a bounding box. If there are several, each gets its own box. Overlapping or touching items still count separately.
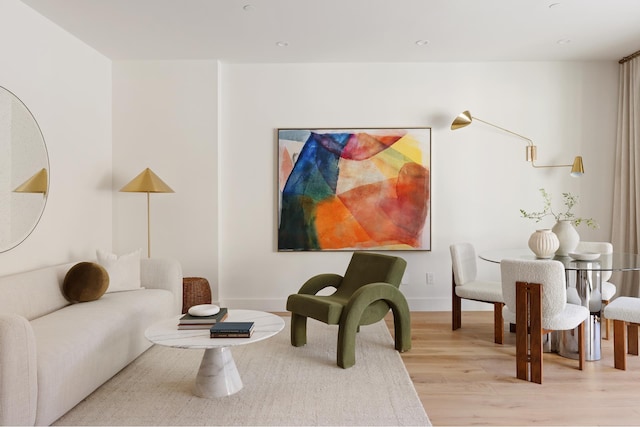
[21,0,640,62]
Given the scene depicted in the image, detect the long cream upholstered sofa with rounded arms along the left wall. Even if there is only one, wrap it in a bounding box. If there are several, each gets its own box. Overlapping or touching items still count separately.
[0,259,182,425]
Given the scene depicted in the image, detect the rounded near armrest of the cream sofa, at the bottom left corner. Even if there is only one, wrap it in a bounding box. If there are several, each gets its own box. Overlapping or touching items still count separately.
[0,314,38,426]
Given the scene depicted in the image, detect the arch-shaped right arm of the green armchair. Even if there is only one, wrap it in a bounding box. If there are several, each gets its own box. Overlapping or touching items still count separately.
[338,282,411,368]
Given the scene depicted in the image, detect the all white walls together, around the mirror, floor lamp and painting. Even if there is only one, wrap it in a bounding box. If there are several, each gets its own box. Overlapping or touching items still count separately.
[0,0,618,310]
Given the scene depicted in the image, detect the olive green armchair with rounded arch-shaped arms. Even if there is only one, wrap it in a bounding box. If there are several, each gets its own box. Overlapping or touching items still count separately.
[287,251,411,369]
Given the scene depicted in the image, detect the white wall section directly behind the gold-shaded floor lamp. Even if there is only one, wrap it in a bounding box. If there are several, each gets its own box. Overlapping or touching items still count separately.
[113,61,219,299]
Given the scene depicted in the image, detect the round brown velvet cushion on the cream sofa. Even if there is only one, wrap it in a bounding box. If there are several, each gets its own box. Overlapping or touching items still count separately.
[62,262,109,302]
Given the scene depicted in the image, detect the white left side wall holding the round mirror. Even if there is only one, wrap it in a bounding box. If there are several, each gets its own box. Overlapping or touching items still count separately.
[0,0,112,274]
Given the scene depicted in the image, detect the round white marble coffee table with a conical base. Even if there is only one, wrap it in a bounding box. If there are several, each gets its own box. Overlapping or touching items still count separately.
[144,310,284,398]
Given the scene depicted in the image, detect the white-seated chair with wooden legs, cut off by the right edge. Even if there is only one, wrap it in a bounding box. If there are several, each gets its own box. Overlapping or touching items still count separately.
[604,297,640,370]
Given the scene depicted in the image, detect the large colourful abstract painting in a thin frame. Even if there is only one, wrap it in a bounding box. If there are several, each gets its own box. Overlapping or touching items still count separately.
[278,128,431,251]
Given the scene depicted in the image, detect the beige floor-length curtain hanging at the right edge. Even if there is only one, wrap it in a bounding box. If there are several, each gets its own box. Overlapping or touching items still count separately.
[611,52,640,297]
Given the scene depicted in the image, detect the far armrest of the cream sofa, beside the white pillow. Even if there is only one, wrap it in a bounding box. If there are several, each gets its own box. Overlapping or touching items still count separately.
[140,258,182,314]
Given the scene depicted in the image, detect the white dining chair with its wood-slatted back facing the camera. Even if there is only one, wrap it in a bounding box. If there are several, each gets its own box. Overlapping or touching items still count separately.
[500,259,590,384]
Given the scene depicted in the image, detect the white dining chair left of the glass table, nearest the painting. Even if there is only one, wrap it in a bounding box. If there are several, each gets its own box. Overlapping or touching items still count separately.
[449,243,504,344]
